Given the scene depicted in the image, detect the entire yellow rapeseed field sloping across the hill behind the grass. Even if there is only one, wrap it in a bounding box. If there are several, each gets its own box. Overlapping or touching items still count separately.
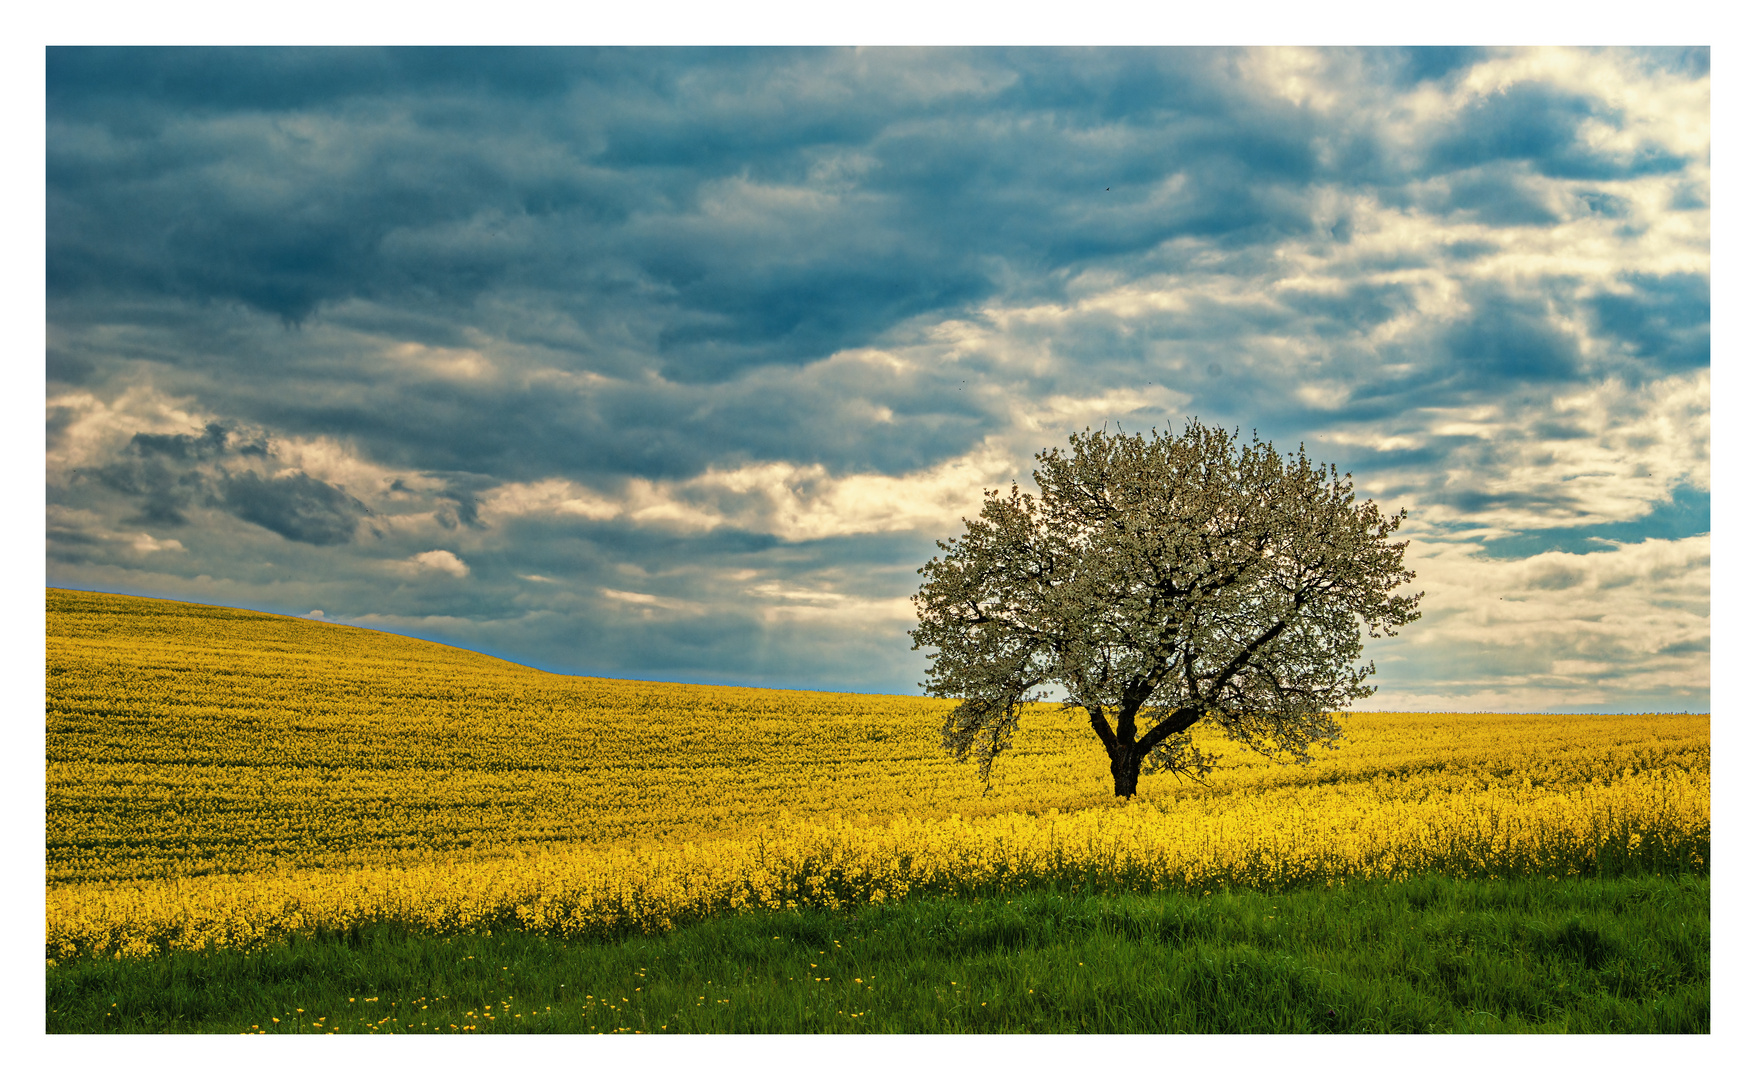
[46,590,1710,959]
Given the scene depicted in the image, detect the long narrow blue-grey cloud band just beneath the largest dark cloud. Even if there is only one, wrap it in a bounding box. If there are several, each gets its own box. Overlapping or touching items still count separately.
[204,345,982,481]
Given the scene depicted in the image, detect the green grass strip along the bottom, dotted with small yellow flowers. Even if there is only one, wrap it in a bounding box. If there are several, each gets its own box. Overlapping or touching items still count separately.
[46,875,1710,1033]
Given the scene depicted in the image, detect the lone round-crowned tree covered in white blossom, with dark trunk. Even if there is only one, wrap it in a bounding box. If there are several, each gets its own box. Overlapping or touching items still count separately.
[913,421,1421,796]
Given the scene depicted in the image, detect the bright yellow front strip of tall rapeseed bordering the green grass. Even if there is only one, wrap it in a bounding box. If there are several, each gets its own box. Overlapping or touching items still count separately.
[47,773,1710,961]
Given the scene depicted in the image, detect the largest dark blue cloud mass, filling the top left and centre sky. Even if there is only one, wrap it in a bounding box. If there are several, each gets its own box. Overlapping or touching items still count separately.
[49,51,1315,379]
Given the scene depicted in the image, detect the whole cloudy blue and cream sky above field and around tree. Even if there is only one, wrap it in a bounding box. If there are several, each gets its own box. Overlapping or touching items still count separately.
[46,49,1710,711]
